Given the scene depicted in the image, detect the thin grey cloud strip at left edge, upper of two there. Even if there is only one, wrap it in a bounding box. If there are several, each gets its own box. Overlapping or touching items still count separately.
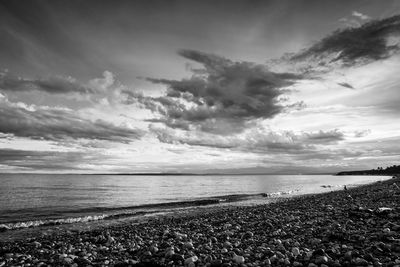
[0,72,94,94]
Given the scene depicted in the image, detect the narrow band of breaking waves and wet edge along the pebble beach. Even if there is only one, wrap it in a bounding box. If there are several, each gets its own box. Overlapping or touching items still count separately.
[0,176,390,233]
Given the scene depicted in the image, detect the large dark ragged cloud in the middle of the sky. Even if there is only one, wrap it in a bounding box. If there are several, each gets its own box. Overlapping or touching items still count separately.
[142,50,302,132]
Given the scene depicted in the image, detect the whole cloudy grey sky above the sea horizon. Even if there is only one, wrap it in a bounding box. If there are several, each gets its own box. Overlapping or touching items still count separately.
[0,0,400,173]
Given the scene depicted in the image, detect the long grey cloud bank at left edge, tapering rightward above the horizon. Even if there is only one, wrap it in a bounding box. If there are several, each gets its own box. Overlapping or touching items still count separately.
[0,99,143,143]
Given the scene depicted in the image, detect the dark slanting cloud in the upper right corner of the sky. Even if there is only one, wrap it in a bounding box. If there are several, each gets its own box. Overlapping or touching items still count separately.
[291,16,400,65]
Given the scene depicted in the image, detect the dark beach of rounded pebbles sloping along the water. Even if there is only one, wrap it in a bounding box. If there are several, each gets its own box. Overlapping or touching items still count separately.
[0,178,400,267]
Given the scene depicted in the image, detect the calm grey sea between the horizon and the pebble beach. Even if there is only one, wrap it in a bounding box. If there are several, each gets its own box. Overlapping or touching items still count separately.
[0,174,388,228]
